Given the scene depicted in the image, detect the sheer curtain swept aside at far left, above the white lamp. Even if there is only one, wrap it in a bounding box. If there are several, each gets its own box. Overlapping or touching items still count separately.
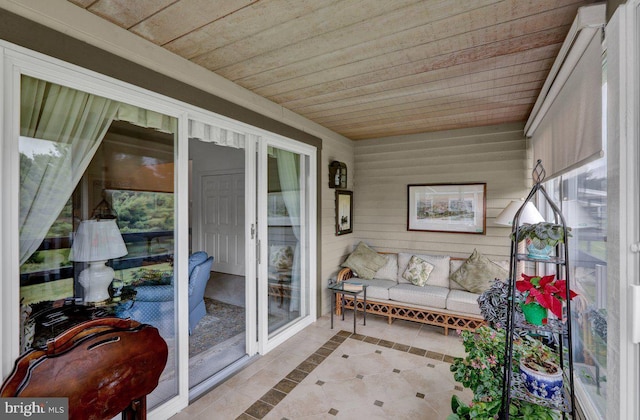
[19,76,119,264]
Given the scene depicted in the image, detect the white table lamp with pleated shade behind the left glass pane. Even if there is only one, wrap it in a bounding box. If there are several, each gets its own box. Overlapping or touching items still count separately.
[69,219,127,303]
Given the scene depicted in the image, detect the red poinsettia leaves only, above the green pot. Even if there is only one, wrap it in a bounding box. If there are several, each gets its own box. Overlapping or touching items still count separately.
[516,274,578,319]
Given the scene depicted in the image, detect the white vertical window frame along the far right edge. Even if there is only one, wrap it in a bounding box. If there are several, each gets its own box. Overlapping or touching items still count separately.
[606,0,640,419]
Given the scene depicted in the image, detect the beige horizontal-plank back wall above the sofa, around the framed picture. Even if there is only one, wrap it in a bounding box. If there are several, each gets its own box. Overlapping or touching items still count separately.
[350,123,532,259]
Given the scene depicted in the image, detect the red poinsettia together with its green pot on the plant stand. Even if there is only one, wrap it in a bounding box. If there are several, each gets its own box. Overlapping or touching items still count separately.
[516,274,578,325]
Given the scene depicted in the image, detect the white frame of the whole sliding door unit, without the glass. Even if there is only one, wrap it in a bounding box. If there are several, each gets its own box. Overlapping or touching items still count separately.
[0,40,318,418]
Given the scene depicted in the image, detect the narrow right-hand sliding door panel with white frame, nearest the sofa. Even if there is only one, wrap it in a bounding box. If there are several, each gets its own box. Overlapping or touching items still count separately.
[258,140,315,349]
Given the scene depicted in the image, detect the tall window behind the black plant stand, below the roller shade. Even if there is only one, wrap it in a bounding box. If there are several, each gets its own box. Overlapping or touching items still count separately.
[541,158,607,418]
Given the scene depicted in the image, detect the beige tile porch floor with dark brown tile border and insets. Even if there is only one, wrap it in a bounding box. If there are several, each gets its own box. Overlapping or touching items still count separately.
[172,312,471,420]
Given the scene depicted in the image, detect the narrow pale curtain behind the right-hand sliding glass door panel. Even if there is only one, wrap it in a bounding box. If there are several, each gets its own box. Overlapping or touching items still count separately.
[273,148,301,311]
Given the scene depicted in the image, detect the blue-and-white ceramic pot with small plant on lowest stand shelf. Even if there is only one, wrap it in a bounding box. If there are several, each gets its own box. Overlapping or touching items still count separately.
[519,337,563,404]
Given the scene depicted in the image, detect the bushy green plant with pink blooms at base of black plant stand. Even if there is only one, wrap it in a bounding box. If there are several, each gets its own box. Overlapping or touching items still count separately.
[447,326,559,420]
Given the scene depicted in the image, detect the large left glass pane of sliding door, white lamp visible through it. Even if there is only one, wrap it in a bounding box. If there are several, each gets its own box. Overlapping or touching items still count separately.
[17,75,178,408]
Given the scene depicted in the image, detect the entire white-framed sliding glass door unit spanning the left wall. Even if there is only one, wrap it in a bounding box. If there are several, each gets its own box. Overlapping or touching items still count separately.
[0,42,317,418]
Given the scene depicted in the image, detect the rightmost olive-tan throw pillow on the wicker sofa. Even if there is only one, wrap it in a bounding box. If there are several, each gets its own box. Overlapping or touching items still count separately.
[451,249,509,293]
